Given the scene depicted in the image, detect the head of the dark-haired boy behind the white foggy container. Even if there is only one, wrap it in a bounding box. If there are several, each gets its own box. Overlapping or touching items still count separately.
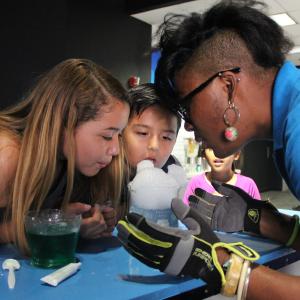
[123,83,181,170]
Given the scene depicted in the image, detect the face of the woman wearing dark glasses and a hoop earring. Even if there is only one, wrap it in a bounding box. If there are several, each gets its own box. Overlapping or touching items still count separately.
[176,70,249,157]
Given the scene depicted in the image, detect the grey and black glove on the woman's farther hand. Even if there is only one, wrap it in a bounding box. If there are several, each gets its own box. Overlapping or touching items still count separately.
[189,181,277,234]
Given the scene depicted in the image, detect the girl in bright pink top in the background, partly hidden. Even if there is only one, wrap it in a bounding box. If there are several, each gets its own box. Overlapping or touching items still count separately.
[183,148,261,205]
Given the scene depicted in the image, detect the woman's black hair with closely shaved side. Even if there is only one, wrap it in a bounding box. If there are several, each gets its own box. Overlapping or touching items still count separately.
[155,0,293,108]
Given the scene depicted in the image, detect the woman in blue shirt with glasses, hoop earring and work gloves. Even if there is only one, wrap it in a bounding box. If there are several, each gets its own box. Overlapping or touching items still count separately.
[119,1,300,299]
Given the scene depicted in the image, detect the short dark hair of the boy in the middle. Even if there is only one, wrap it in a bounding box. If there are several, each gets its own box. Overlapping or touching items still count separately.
[128,83,181,132]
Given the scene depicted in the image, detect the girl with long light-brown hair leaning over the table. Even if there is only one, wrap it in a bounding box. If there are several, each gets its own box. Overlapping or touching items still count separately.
[0,59,129,252]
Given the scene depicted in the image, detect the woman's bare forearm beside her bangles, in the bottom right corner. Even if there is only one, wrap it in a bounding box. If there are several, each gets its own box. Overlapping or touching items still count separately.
[246,266,300,300]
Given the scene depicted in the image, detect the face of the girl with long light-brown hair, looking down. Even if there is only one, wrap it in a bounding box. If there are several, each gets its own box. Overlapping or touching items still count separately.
[63,99,129,177]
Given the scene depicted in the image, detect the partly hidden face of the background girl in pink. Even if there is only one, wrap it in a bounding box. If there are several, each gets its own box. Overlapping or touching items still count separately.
[204,148,239,173]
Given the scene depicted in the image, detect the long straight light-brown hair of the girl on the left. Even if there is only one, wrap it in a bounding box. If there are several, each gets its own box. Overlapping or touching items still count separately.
[0,59,128,253]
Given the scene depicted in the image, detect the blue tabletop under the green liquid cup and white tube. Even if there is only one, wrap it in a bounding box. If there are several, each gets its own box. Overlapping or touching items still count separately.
[0,233,299,300]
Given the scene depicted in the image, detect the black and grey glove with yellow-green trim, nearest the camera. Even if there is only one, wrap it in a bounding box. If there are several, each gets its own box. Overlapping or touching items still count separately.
[117,199,259,292]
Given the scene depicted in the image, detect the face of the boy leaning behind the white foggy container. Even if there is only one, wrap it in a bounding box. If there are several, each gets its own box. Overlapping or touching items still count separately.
[123,105,177,168]
